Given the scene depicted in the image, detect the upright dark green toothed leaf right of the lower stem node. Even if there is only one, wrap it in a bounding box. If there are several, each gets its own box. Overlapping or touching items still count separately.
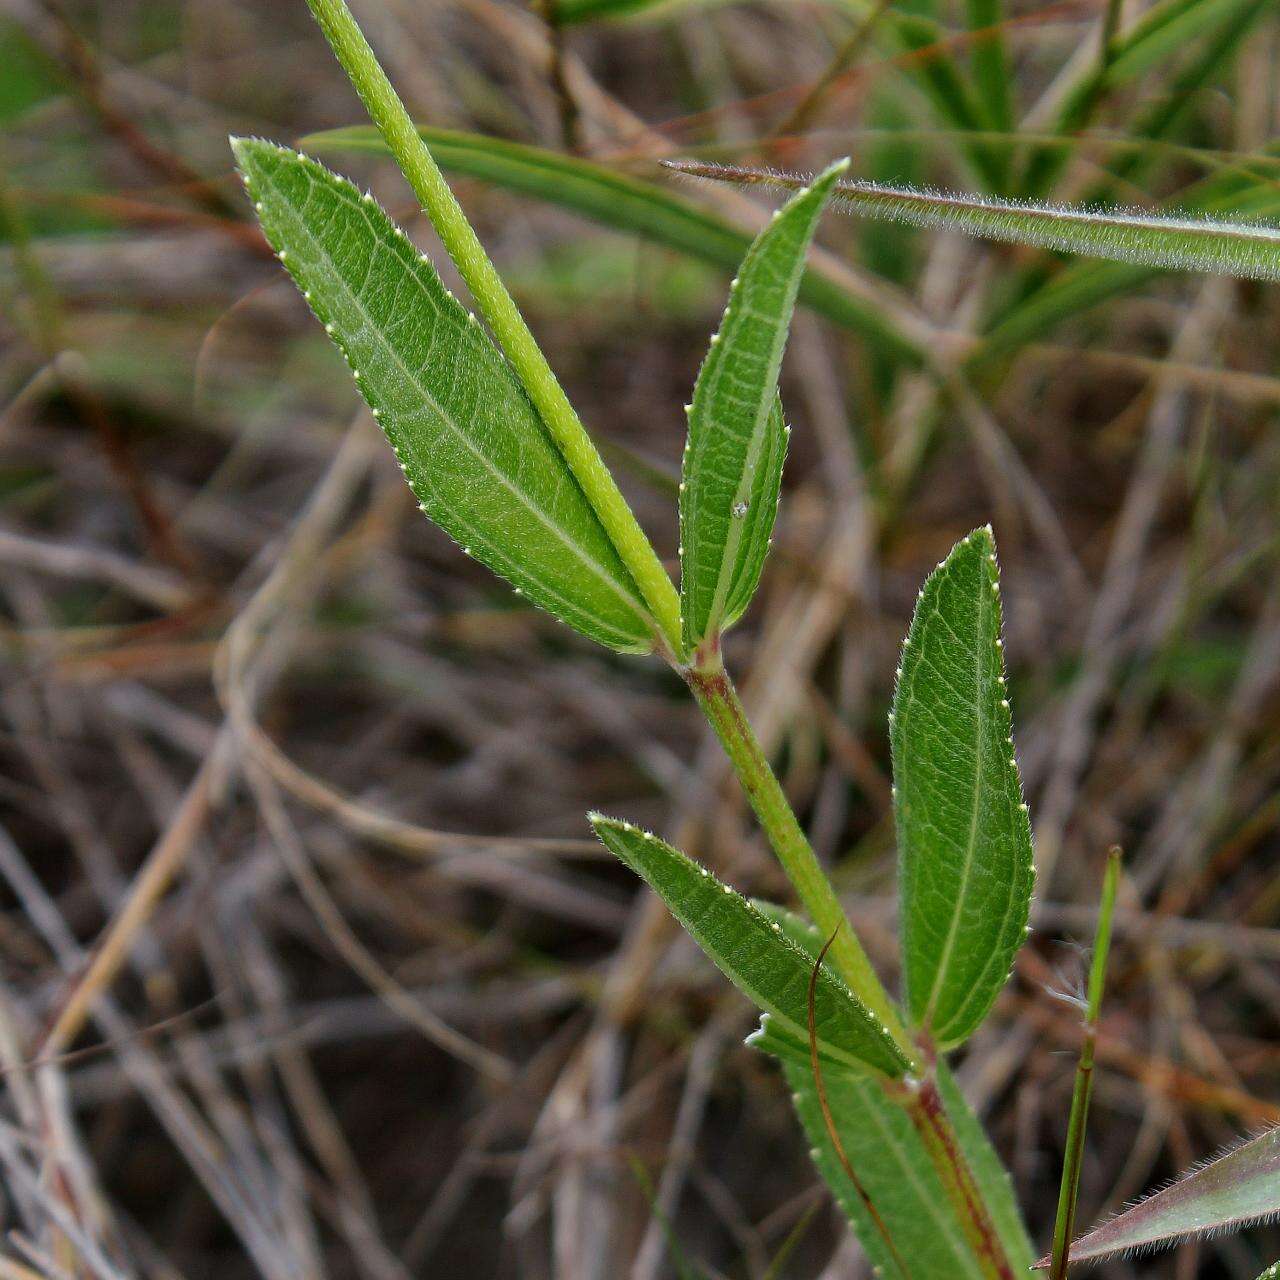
[890,529,1034,1048]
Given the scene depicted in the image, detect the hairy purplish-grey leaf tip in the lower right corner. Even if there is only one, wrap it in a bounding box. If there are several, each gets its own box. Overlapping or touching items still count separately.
[1054,1128,1280,1264]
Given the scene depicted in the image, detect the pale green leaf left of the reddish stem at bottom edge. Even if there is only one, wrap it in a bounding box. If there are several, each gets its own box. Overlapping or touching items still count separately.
[783,1061,986,1280]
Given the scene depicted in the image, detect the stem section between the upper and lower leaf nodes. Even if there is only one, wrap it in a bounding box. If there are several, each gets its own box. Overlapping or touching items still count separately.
[681,658,919,1069]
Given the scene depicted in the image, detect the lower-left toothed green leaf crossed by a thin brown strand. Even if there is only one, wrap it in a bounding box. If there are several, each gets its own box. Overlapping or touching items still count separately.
[590,813,908,1076]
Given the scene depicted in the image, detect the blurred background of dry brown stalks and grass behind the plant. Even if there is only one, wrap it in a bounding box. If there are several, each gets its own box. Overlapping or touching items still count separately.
[0,0,1280,1280]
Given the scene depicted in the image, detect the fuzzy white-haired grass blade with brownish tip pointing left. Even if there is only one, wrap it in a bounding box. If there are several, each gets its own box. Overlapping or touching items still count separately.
[671,160,1280,280]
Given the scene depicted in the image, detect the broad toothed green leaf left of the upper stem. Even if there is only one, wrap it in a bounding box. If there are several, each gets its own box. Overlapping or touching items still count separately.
[233,138,653,653]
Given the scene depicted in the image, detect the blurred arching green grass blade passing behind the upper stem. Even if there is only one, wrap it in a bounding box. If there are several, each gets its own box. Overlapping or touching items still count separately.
[303,125,922,362]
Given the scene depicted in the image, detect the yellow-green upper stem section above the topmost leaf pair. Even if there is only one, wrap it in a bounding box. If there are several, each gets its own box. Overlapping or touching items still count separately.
[307,0,682,655]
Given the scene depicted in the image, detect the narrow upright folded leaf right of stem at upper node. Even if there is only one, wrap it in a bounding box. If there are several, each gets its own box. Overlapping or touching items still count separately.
[680,160,849,653]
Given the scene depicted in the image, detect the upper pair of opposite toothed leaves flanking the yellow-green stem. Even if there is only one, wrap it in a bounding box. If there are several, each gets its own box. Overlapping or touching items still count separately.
[233,140,846,654]
